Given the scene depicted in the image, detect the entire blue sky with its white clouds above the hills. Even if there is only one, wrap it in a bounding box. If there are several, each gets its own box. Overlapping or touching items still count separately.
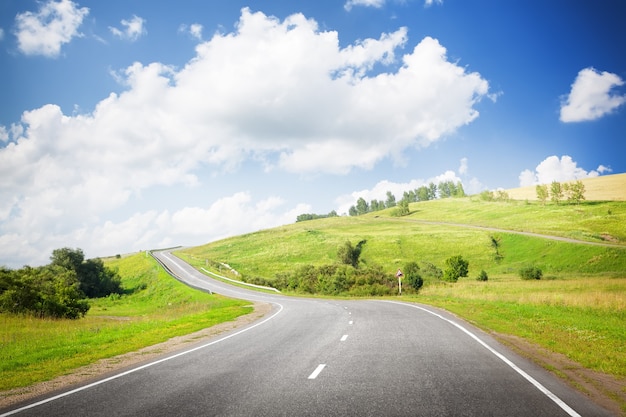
[0,0,626,267]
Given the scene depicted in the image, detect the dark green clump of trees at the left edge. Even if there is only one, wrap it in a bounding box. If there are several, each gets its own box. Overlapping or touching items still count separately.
[0,248,122,319]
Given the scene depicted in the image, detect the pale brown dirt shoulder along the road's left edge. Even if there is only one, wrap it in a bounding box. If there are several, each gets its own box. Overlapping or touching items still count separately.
[0,303,272,408]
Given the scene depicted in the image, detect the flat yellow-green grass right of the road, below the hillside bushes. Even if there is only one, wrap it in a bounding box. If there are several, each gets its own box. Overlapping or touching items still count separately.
[407,276,626,378]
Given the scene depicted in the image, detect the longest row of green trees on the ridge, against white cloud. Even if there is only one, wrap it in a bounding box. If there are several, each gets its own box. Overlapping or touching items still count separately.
[348,181,465,216]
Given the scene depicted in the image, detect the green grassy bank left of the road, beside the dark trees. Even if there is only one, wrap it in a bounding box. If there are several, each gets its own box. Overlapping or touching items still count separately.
[0,254,252,391]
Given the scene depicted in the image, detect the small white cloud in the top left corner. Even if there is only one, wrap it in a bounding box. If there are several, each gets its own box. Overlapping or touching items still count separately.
[15,0,89,58]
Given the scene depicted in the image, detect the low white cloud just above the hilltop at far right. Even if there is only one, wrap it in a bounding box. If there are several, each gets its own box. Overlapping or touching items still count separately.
[519,155,611,187]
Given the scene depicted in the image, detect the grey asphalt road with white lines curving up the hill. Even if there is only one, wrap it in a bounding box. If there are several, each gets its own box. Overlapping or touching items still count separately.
[0,253,610,417]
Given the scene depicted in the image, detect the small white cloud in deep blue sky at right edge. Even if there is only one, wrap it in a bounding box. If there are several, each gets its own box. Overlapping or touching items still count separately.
[560,68,626,122]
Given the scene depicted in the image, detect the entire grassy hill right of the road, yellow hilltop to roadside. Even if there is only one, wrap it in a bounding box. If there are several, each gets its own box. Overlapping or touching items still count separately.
[179,174,626,415]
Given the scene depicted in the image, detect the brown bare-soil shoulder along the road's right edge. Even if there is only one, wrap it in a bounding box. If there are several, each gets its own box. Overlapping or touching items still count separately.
[493,333,626,417]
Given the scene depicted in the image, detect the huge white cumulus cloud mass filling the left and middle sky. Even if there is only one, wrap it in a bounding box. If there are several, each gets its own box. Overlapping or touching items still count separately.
[0,9,489,263]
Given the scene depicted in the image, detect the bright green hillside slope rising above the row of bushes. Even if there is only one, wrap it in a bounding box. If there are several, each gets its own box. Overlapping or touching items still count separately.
[178,197,626,280]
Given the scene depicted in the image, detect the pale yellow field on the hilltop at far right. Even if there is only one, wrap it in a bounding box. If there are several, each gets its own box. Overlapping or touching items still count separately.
[507,174,626,201]
